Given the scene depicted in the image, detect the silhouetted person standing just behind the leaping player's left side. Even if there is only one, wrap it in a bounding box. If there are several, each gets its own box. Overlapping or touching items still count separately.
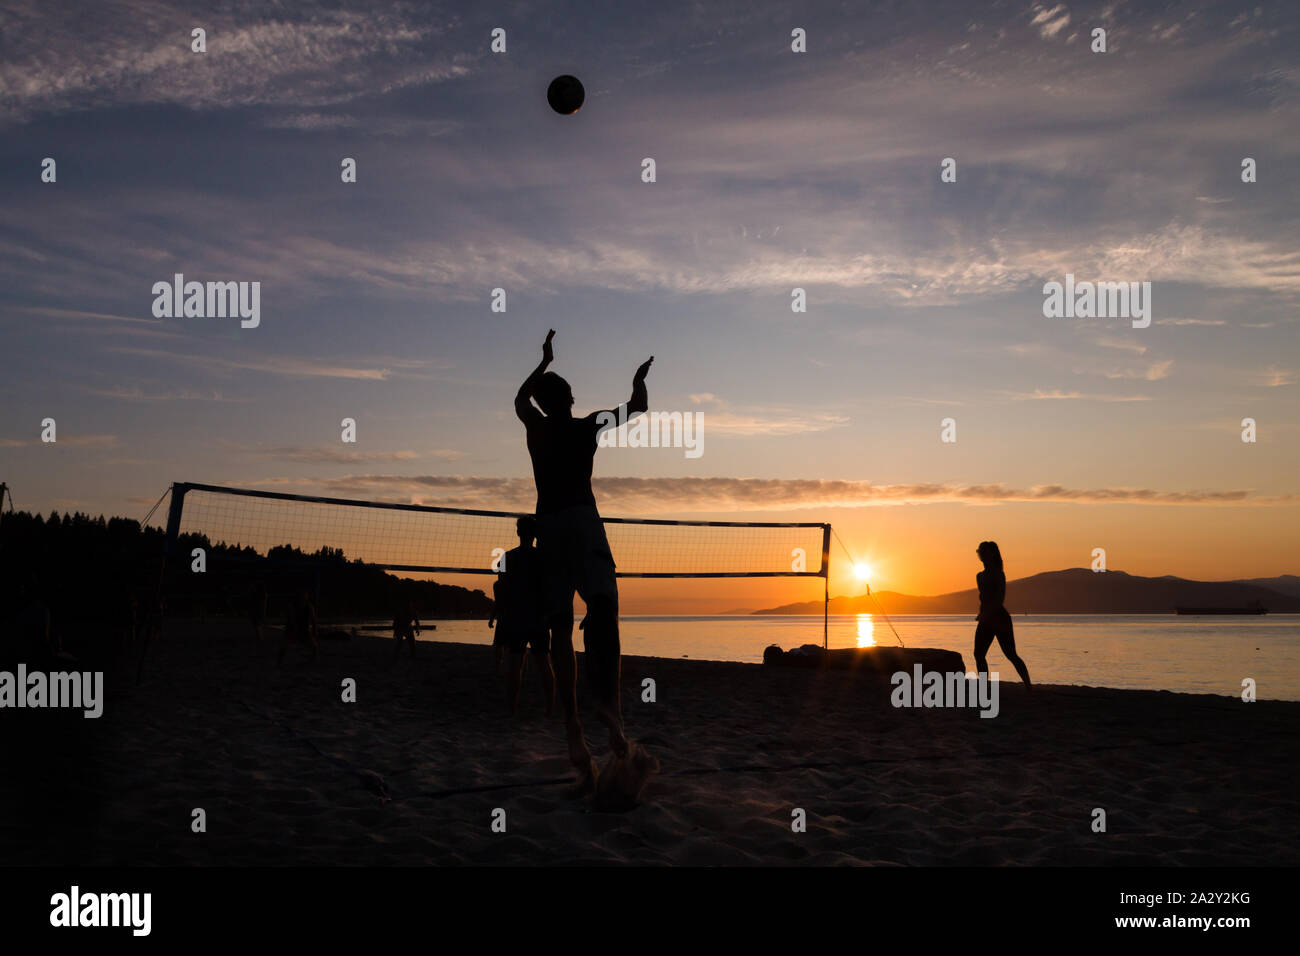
[493,516,551,717]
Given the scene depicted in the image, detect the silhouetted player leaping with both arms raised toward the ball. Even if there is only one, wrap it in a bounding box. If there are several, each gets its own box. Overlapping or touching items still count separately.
[515,329,654,791]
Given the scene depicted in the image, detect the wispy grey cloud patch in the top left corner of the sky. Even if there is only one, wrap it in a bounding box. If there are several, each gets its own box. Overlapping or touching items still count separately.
[0,0,473,120]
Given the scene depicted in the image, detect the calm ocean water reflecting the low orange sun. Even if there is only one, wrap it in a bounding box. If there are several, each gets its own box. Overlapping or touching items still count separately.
[377,614,1300,700]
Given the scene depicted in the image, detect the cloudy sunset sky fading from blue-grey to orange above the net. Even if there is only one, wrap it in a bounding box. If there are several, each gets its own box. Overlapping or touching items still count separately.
[0,0,1300,604]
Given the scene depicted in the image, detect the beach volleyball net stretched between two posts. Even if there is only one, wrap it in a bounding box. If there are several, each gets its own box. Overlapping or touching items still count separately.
[159,483,831,578]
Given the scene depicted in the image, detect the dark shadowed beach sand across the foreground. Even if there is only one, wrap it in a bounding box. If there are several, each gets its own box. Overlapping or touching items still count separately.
[0,624,1300,866]
